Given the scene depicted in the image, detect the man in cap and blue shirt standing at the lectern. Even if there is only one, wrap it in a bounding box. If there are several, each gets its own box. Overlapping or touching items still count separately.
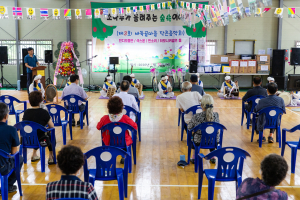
[24,47,40,94]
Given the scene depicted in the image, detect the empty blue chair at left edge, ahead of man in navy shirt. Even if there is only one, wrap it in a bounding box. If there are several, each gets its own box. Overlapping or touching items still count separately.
[0,95,27,123]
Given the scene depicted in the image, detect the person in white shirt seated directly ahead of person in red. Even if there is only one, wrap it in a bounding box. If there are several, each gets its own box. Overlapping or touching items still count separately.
[114,81,139,122]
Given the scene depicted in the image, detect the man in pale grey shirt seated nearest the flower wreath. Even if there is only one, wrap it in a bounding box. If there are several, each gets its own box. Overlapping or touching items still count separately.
[61,74,88,126]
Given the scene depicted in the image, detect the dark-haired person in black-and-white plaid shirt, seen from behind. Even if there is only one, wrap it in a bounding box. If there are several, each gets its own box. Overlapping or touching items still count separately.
[46,145,98,200]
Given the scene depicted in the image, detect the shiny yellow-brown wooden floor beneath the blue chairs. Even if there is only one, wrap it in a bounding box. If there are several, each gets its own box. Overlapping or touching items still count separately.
[1,90,300,200]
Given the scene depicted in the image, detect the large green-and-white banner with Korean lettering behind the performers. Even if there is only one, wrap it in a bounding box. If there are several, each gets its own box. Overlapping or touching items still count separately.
[91,2,207,73]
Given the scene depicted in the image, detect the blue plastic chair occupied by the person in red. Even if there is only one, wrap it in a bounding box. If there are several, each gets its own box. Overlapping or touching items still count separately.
[100,122,137,173]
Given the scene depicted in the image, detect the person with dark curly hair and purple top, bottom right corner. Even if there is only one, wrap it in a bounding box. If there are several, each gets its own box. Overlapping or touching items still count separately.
[236,154,288,200]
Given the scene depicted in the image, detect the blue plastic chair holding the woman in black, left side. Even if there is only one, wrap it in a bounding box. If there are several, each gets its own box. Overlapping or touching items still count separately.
[14,121,56,172]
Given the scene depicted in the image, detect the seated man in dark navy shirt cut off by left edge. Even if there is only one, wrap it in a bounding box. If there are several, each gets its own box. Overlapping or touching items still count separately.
[0,103,23,193]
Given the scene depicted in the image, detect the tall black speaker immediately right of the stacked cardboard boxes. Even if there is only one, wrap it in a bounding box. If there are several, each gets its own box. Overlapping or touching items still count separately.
[271,49,285,76]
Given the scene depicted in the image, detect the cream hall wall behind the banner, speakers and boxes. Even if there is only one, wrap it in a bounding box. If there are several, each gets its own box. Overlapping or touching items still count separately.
[0,0,300,87]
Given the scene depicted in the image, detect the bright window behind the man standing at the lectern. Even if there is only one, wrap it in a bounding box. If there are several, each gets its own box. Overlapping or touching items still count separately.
[0,40,53,65]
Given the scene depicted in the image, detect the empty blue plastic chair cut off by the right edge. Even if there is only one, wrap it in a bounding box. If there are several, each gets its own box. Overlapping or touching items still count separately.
[281,125,300,174]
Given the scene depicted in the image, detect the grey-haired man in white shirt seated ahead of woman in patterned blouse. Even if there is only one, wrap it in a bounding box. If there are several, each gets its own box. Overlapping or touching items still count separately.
[176,81,202,124]
